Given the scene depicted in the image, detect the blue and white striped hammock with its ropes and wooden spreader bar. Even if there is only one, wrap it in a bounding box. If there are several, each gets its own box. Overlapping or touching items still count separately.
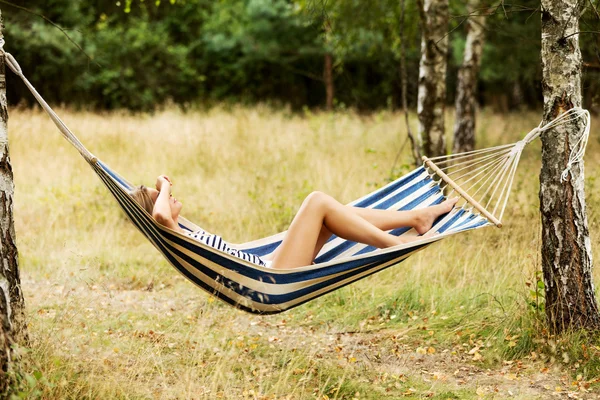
[0,47,590,314]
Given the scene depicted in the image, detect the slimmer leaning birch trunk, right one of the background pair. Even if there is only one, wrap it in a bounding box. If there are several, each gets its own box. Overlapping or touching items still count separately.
[452,0,485,153]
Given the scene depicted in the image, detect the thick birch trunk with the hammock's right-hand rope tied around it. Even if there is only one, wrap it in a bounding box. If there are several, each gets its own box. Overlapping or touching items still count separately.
[540,0,600,333]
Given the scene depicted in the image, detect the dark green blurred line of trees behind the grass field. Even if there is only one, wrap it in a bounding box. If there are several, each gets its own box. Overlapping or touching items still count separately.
[3,0,600,111]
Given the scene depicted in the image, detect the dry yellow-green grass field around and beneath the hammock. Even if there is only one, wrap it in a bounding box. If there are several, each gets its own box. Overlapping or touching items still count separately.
[9,107,600,399]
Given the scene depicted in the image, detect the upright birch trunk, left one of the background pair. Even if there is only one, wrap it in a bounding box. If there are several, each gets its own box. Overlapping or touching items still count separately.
[417,0,448,157]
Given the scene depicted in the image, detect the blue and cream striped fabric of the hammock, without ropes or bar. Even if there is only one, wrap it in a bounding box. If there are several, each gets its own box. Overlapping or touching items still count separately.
[91,161,490,314]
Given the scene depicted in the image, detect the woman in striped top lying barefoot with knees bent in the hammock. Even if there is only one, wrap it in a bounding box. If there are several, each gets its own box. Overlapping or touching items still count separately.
[131,175,458,268]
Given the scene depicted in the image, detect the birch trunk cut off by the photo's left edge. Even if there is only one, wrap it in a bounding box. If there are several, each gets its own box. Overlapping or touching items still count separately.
[0,12,26,397]
